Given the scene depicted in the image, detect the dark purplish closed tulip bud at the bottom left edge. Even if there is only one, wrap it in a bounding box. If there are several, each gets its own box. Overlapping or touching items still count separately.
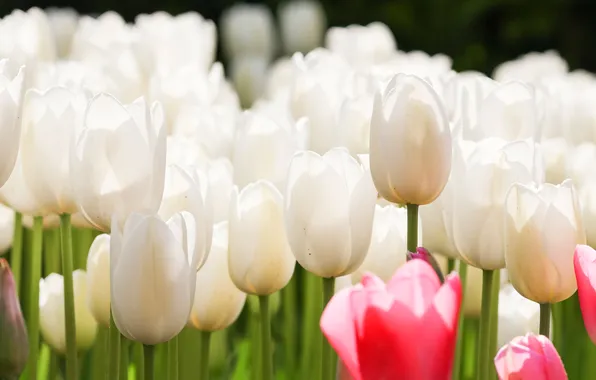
[0,259,29,379]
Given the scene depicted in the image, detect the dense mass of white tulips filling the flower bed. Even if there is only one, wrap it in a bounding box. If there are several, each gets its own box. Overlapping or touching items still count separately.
[0,0,596,378]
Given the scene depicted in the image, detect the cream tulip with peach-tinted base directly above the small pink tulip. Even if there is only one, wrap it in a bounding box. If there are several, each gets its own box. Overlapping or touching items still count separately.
[504,180,586,303]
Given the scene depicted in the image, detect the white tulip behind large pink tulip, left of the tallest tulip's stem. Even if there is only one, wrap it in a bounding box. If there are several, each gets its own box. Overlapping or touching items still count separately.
[352,205,407,283]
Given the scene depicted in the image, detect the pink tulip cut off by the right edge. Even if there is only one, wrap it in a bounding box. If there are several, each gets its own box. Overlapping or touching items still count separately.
[573,245,596,344]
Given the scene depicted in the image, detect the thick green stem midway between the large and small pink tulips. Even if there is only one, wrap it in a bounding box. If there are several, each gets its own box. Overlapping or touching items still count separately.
[476,270,494,380]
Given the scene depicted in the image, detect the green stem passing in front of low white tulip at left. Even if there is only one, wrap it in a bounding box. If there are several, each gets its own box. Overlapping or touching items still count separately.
[60,214,77,380]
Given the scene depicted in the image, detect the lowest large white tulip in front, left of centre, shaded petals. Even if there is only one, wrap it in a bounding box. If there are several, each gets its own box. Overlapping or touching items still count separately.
[110,211,205,345]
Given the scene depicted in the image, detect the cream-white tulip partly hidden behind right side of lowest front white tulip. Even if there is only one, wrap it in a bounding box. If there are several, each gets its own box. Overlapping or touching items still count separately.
[188,222,246,331]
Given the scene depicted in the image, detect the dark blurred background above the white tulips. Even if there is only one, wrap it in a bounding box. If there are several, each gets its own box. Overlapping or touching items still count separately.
[0,0,596,74]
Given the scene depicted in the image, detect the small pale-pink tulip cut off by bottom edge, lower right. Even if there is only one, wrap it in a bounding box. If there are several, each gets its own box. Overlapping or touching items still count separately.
[495,333,567,380]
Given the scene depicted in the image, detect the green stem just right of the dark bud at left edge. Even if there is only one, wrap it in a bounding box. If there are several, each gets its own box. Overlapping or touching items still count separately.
[27,216,44,380]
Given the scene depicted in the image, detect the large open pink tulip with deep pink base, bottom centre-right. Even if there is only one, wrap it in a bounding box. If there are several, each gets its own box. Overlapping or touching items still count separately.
[321,260,462,380]
